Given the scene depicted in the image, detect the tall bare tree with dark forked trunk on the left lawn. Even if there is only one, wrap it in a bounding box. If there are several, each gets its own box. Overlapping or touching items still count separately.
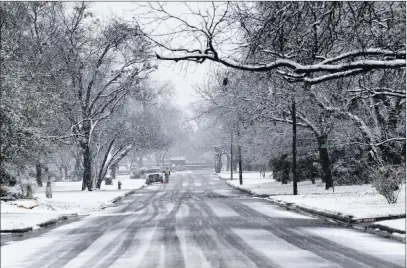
[56,3,154,190]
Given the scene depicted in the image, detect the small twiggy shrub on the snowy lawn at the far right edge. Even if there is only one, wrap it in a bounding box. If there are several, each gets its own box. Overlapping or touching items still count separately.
[371,165,406,204]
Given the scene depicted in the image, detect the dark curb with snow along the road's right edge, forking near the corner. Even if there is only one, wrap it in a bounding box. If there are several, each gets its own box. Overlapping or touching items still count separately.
[220,174,406,240]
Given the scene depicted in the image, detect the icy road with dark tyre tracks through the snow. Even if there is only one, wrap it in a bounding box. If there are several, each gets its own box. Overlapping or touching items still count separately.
[1,172,405,268]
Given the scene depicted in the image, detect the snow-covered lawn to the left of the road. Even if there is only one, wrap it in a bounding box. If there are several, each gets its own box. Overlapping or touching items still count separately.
[1,175,145,230]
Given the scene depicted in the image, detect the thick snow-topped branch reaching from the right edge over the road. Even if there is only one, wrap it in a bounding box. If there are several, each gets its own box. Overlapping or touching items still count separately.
[156,48,406,84]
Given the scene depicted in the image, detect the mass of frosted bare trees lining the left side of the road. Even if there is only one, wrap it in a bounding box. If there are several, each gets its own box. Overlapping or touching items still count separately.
[0,2,188,194]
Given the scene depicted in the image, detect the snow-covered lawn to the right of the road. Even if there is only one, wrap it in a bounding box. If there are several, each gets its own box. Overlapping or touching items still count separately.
[219,173,406,229]
